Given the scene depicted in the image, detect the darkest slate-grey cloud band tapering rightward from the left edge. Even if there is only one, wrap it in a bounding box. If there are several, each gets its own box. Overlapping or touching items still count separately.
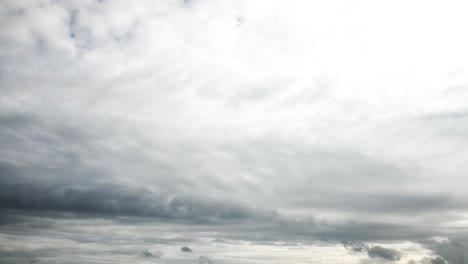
[0,170,275,222]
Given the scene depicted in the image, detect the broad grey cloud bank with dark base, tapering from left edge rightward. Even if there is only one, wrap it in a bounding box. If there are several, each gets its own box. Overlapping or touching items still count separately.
[0,72,467,245]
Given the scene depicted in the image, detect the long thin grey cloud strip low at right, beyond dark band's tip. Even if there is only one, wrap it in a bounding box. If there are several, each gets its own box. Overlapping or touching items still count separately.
[216,215,438,244]
